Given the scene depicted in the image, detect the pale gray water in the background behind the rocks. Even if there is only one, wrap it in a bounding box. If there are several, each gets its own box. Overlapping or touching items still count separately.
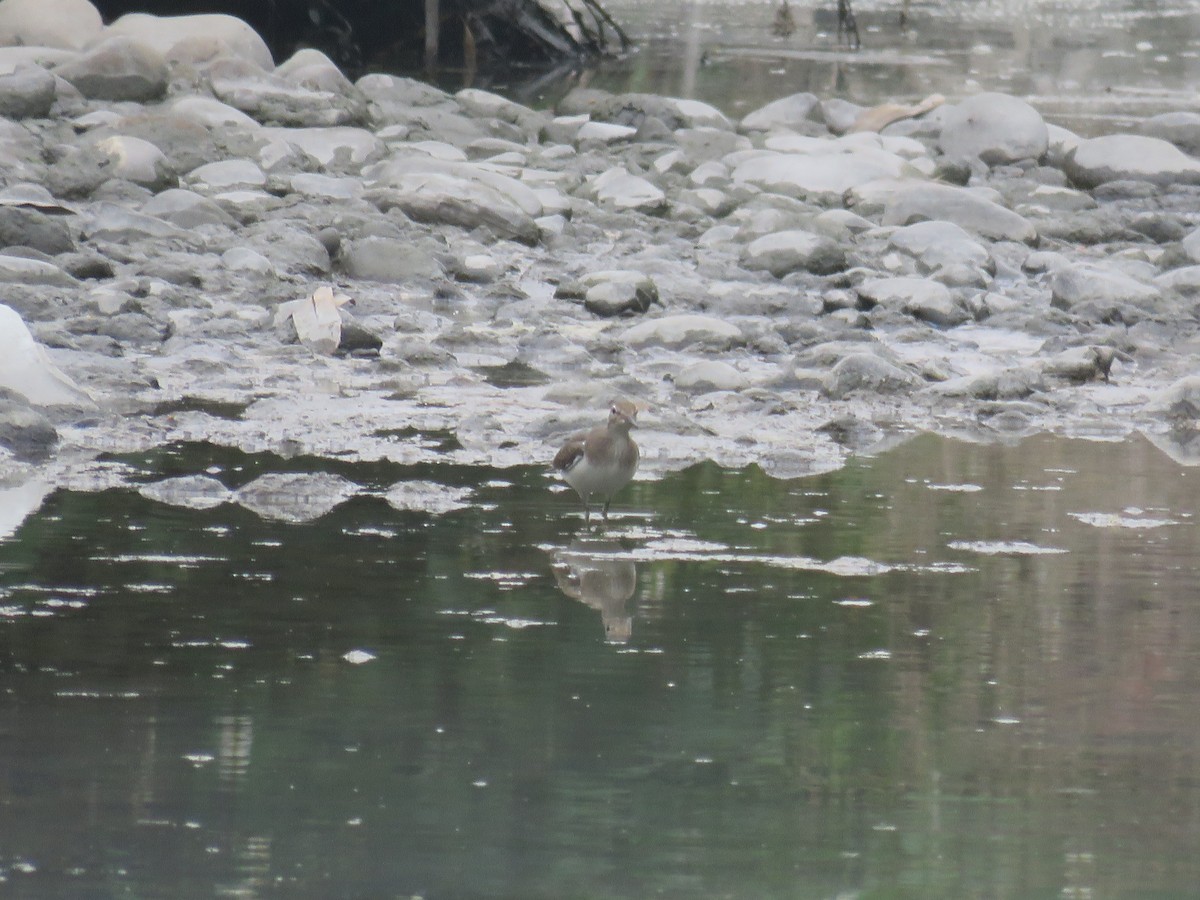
[465,0,1200,136]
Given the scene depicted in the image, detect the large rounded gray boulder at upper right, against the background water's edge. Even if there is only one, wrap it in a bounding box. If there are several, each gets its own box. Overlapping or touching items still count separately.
[937,92,1049,166]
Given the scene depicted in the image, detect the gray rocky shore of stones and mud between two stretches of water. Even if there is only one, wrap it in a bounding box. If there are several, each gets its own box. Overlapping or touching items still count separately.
[0,0,1200,511]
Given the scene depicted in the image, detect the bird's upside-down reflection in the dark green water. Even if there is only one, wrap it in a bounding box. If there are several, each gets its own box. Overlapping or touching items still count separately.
[551,538,637,643]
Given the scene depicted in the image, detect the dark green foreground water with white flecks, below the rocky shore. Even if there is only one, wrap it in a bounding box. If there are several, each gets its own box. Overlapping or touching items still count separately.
[0,437,1200,898]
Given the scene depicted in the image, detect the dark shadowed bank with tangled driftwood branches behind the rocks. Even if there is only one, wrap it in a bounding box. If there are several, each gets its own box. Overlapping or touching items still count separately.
[94,0,630,74]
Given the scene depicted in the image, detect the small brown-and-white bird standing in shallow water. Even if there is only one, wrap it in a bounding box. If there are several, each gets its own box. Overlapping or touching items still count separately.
[553,398,640,526]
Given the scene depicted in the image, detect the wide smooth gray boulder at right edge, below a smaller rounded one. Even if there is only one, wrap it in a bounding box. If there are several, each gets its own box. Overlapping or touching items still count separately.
[1063,134,1200,188]
